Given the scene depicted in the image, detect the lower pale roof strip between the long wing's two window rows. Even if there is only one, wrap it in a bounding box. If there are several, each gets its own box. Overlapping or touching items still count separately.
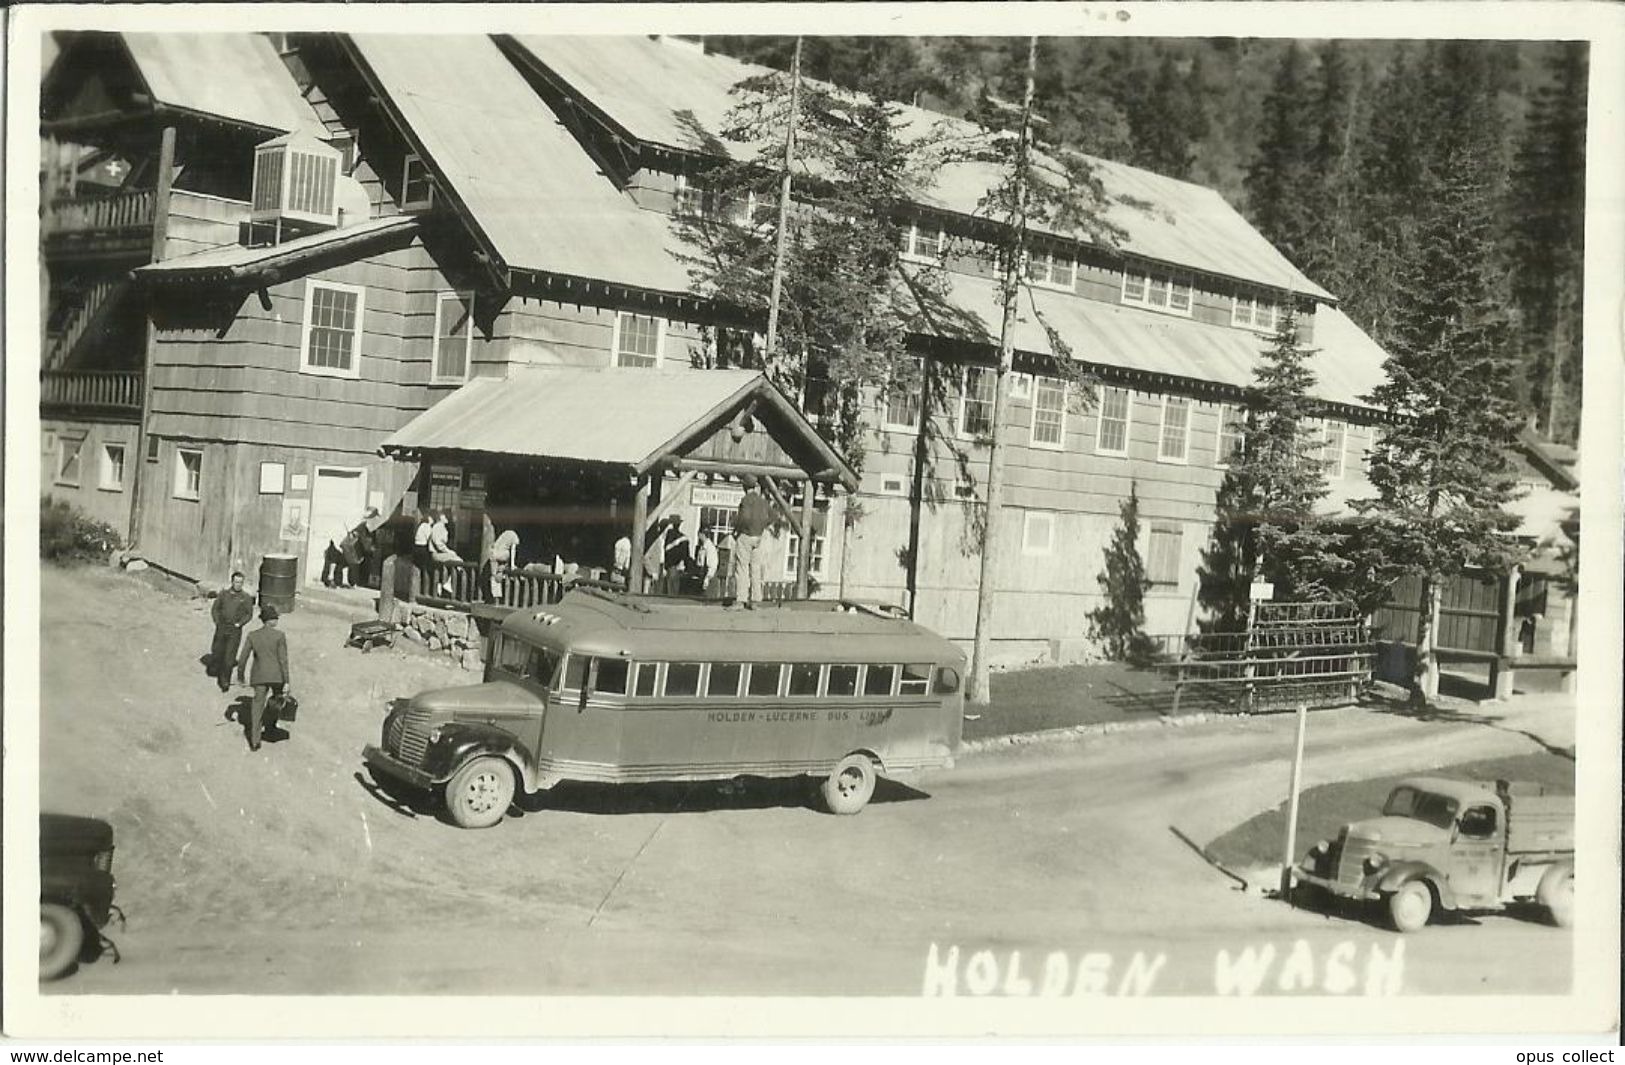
[934,275,1386,406]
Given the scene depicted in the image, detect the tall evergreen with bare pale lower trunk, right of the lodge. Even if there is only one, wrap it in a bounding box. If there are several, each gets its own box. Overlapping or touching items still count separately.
[1357,42,1523,699]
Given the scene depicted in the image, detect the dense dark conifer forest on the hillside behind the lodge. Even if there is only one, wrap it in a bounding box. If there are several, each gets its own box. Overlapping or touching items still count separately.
[707,37,1588,441]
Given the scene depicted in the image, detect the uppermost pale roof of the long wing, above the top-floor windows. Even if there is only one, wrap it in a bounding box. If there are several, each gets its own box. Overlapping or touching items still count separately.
[514,34,1333,299]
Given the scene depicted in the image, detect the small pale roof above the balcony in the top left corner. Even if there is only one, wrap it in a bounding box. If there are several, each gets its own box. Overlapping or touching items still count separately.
[120,33,328,138]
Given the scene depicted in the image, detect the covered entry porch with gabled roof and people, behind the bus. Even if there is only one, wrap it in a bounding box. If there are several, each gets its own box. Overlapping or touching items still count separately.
[380,366,856,606]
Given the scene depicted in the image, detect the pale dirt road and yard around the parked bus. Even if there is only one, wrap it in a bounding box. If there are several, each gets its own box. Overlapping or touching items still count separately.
[41,571,1571,995]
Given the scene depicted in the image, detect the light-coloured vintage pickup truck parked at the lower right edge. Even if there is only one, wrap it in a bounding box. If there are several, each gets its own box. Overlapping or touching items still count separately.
[1294,777,1575,932]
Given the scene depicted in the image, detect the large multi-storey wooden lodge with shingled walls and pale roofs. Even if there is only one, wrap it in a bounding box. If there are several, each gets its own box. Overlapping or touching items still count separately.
[41,34,1430,660]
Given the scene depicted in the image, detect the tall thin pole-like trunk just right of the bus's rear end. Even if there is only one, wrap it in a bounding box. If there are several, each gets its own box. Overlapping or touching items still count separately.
[965,37,1038,706]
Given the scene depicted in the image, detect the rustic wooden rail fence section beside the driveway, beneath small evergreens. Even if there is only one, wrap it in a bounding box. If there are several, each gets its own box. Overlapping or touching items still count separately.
[1160,603,1375,712]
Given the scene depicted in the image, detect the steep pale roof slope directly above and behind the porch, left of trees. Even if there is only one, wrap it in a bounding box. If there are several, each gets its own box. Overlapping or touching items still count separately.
[351,34,689,293]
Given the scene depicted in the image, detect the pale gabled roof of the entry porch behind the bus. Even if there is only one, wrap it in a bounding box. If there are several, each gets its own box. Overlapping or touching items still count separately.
[379,366,858,488]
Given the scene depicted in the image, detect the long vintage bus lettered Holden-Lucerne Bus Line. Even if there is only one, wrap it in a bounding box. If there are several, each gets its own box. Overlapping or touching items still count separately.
[362,587,965,828]
